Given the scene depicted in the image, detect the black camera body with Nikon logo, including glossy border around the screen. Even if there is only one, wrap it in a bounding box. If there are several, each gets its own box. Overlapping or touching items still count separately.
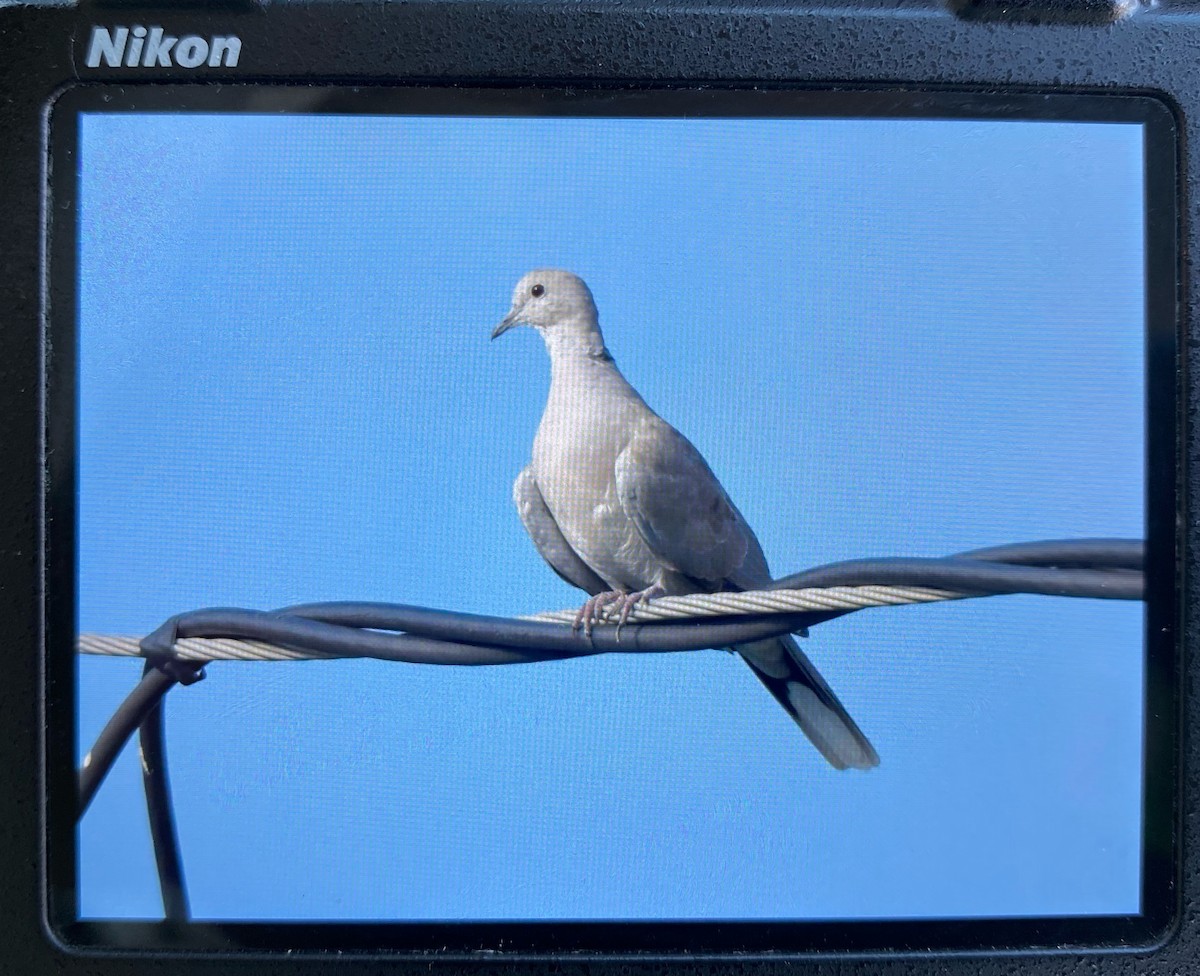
[0,0,1200,974]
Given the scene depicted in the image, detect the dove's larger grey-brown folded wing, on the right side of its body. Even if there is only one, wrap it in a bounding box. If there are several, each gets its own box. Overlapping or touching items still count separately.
[616,418,758,583]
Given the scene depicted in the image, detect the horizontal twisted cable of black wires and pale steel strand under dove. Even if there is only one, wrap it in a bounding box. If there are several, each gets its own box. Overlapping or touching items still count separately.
[79,539,1145,665]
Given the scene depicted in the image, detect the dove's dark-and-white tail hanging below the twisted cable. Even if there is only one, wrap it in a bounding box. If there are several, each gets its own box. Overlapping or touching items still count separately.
[734,637,880,770]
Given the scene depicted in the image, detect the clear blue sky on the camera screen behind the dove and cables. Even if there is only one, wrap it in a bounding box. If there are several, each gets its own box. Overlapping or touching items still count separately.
[72,114,1144,920]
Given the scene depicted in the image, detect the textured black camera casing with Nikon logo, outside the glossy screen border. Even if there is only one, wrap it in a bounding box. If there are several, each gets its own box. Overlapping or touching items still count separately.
[0,0,1200,974]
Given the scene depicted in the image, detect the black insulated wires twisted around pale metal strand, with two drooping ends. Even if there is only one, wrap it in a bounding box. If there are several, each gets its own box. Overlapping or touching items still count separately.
[77,539,1145,921]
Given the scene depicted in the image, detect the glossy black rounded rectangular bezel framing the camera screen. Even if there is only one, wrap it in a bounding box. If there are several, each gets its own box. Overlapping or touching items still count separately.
[43,85,1183,958]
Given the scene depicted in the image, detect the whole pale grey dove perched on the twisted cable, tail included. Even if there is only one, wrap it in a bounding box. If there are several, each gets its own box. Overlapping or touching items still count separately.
[492,270,880,770]
